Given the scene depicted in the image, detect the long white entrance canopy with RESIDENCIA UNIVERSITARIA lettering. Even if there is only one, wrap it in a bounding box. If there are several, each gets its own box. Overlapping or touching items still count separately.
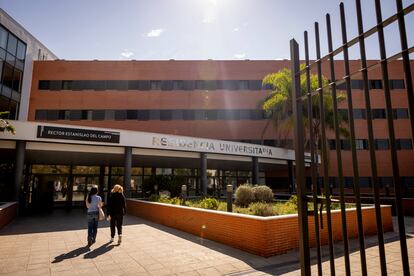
[0,121,310,170]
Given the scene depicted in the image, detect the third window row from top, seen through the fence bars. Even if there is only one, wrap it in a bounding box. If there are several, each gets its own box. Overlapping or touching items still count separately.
[328,139,413,150]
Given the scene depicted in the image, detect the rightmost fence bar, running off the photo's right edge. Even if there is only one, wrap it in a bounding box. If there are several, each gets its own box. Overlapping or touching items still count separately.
[396,0,414,140]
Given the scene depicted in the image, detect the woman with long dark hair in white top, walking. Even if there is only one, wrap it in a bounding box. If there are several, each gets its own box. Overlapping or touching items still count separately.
[86,187,102,247]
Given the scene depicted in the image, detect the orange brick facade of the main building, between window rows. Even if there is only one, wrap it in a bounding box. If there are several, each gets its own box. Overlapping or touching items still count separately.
[29,61,414,185]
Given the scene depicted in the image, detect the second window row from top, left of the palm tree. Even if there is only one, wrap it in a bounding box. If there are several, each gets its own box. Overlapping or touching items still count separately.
[35,109,270,121]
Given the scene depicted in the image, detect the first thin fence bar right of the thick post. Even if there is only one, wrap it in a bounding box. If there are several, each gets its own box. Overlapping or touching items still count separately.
[304,31,322,275]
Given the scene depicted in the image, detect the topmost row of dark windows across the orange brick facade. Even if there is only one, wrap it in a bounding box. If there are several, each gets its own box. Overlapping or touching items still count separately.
[39,80,405,91]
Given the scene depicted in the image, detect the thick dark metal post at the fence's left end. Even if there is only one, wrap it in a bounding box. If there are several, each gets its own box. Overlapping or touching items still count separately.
[290,39,311,275]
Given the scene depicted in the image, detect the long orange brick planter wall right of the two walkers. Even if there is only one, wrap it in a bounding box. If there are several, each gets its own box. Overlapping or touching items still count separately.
[127,199,393,257]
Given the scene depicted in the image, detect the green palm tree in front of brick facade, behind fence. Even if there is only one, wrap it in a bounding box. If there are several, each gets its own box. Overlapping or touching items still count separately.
[260,64,348,149]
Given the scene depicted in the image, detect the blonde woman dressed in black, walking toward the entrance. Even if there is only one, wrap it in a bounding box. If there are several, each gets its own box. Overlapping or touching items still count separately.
[107,184,126,244]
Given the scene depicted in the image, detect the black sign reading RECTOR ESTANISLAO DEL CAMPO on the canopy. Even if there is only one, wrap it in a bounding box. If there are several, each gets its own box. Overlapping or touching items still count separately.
[37,126,120,144]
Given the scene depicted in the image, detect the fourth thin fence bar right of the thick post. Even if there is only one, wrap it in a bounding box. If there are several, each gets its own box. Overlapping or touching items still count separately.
[339,3,352,275]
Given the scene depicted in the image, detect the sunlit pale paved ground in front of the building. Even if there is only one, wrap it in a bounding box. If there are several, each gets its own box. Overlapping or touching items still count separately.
[0,210,414,276]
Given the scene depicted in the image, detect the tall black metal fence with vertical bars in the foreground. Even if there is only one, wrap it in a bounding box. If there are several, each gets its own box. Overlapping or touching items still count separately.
[290,0,414,275]
